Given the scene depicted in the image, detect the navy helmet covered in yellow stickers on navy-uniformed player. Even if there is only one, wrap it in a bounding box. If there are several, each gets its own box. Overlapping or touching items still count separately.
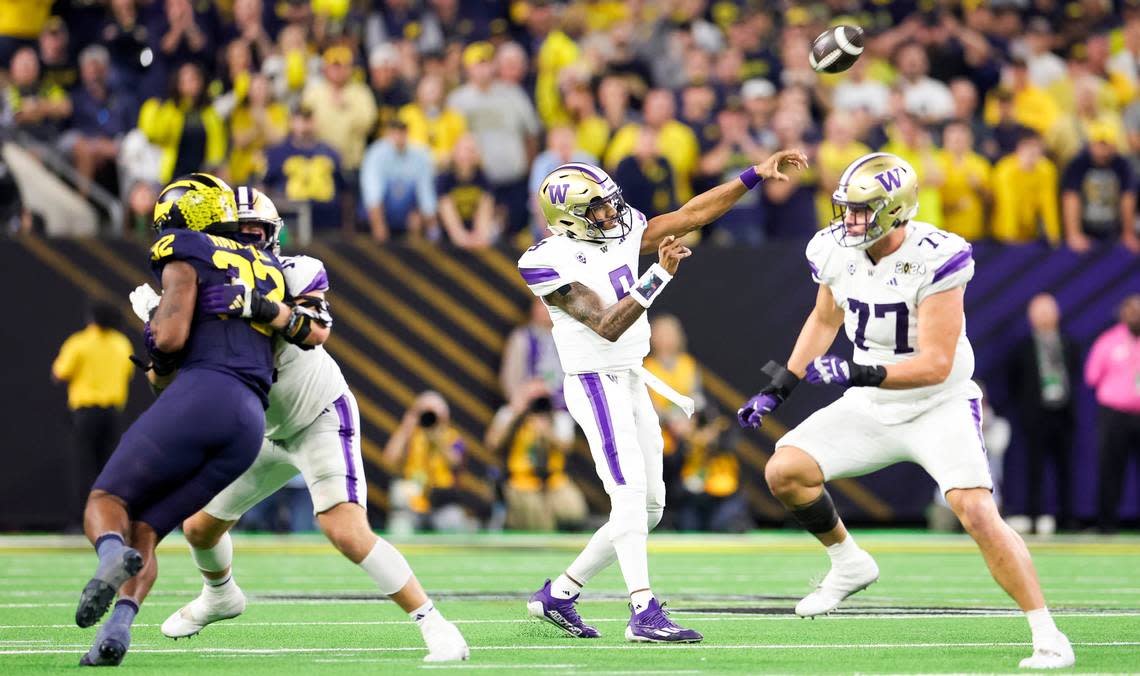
[152,173,238,236]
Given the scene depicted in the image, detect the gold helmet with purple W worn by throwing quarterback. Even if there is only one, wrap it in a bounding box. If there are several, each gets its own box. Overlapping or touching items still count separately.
[538,162,633,242]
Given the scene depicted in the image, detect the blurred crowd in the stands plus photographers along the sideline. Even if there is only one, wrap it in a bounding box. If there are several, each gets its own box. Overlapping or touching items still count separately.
[15,0,1140,530]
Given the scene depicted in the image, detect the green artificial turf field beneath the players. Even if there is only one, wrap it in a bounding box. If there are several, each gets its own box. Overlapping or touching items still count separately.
[0,531,1140,676]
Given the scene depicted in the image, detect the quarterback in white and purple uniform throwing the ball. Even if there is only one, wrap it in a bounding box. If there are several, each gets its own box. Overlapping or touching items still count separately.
[519,150,807,643]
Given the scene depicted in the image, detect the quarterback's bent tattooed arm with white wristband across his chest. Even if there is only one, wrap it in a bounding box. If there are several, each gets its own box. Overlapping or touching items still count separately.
[544,235,693,343]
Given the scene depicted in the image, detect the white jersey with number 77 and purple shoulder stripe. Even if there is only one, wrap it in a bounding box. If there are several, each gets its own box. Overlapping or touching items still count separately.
[807,221,982,423]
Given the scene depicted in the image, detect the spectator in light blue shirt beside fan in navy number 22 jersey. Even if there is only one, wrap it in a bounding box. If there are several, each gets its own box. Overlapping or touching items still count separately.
[360,119,437,242]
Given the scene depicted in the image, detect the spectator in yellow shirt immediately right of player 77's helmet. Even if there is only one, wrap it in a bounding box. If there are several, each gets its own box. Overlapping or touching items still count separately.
[938,122,991,242]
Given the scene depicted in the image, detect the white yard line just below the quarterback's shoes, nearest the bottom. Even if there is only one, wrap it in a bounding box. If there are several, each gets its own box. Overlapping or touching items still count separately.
[0,641,1140,655]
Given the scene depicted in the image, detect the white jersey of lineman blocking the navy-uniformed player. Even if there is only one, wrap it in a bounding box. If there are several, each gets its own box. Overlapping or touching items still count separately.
[266,255,348,441]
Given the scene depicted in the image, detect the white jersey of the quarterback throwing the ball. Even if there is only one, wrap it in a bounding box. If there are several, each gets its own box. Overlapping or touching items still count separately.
[519,207,649,374]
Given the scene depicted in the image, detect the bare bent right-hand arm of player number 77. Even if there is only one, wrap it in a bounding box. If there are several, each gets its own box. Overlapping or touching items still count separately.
[879,286,966,390]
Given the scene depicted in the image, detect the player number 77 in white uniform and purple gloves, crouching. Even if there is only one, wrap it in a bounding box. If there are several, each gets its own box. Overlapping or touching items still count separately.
[739,153,1074,668]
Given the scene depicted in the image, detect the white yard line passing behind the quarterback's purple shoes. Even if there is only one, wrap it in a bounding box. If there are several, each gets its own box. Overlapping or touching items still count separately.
[0,610,1140,629]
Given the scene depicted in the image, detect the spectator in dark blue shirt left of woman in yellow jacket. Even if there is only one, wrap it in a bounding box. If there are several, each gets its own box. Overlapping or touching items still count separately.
[59,44,135,194]
